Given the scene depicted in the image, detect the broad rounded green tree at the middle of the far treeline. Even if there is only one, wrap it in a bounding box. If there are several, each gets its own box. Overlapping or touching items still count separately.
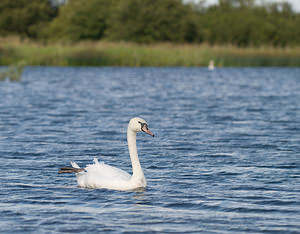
[106,0,198,43]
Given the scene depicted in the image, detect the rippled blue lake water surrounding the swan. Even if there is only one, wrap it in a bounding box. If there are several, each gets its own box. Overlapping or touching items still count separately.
[0,67,300,233]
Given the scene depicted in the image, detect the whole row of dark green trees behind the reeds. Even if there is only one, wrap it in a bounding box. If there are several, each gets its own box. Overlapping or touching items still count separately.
[0,0,300,47]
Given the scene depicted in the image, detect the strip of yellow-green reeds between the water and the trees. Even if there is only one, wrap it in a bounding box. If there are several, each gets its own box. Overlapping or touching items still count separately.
[0,37,300,67]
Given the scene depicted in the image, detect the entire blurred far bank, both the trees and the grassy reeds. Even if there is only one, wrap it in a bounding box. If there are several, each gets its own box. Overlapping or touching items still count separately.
[0,0,300,67]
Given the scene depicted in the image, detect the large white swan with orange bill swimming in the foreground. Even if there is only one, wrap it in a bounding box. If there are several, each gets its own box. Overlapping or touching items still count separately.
[58,117,154,190]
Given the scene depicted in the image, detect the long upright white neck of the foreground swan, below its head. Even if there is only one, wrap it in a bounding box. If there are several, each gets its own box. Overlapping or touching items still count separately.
[127,127,144,179]
